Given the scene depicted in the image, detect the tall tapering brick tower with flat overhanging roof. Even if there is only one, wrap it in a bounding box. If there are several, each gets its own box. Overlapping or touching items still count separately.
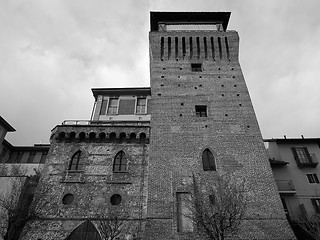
[145,12,294,239]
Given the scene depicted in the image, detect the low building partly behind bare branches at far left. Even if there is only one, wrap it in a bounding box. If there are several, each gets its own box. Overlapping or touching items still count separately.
[0,116,50,239]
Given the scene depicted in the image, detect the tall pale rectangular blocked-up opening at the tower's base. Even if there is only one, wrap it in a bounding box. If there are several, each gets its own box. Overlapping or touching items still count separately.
[177,192,193,232]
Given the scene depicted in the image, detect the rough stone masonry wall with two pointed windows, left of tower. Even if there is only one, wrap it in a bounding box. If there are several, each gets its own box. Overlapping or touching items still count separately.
[25,126,149,240]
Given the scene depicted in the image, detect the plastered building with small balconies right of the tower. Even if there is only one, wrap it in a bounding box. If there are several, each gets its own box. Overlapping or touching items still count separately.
[264,136,320,238]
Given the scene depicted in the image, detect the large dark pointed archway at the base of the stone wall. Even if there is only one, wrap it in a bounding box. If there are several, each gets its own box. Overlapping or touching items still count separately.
[65,220,101,240]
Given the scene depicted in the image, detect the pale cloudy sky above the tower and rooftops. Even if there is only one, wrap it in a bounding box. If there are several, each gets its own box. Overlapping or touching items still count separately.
[0,0,320,145]
